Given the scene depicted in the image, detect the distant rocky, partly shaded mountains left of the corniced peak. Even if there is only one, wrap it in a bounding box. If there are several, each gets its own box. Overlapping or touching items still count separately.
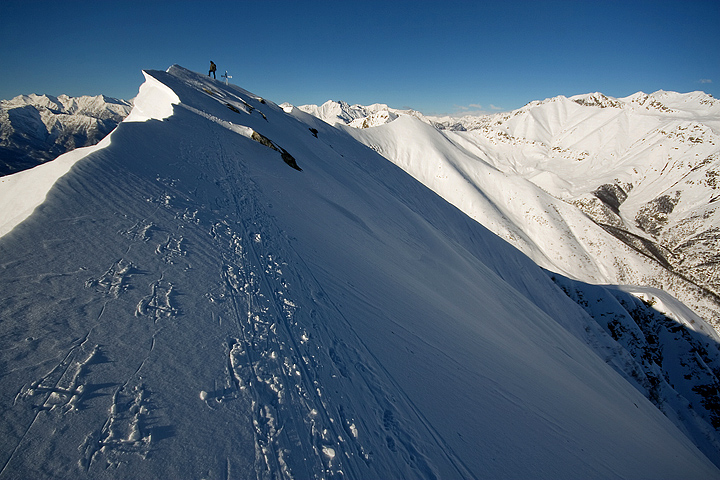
[0,94,132,175]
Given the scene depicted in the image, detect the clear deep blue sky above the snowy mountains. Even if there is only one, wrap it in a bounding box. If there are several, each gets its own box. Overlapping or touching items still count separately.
[0,0,720,114]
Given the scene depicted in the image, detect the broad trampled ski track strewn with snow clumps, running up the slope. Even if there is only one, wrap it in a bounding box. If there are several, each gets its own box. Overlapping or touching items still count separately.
[186,127,472,479]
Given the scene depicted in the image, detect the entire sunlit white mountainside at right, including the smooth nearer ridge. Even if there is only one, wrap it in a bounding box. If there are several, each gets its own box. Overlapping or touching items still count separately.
[301,91,720,327]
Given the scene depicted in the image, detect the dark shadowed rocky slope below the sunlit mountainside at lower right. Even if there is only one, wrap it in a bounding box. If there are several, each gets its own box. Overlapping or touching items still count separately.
[550,273,720,458]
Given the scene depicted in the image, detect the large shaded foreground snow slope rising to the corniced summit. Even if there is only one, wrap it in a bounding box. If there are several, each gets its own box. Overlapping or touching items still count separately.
[0,66,720,478]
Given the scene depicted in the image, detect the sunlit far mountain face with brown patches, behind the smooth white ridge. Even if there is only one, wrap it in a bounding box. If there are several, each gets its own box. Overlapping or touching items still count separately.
[450,92,720,323]
